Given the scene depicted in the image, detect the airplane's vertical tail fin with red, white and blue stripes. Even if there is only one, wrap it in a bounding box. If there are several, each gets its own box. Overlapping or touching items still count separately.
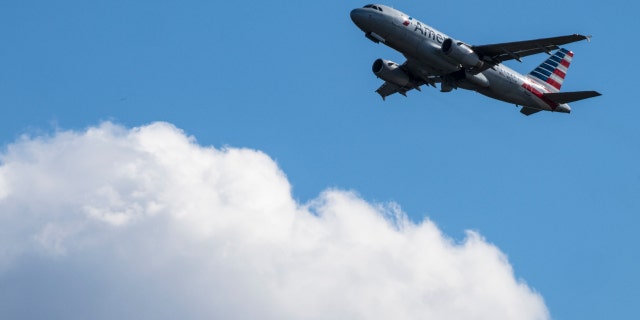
[529,48,573,92]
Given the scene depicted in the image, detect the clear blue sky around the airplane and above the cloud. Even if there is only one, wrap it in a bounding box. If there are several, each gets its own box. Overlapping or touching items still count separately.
[0,0,640,319]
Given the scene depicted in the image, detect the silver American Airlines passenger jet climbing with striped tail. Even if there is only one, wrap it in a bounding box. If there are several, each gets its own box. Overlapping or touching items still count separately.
[351,4,601,116]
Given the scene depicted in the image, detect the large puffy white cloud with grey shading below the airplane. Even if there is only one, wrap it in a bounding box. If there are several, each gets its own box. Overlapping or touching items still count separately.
[0,123,549,320]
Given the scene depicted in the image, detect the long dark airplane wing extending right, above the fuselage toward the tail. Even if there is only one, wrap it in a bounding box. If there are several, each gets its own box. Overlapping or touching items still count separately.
[472,34,591,64]
